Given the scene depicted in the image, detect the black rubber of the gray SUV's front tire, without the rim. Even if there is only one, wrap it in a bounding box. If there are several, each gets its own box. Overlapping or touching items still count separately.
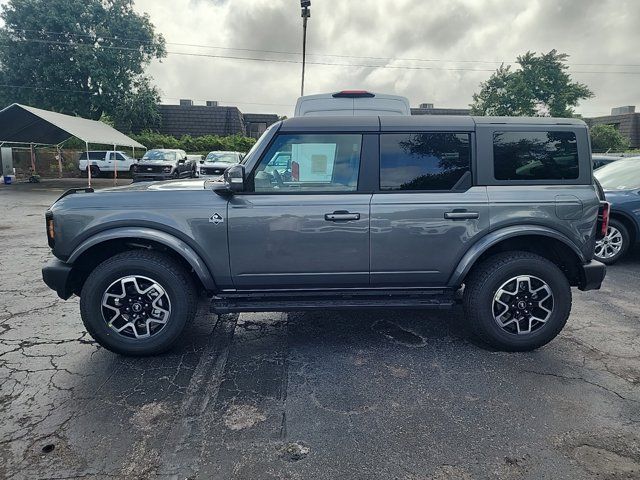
[80,259,189,355]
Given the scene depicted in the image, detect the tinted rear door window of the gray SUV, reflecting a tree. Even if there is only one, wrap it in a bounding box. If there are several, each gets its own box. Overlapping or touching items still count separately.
[380,132,471,190]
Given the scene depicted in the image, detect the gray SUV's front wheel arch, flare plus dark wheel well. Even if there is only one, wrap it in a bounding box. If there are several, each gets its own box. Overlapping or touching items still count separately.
[67,227,216,294]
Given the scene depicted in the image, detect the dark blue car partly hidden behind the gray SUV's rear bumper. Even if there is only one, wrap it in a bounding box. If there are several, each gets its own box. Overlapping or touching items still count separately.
[595,157,640,265]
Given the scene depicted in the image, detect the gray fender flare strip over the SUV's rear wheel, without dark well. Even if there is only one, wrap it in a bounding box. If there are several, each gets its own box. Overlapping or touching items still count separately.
[448,225,586,287]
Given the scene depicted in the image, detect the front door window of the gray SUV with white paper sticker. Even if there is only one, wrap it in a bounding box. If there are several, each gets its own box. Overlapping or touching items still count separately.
[253,134,362,192]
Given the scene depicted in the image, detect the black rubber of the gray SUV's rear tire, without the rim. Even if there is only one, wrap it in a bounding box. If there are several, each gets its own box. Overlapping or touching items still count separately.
[476,259,571,350]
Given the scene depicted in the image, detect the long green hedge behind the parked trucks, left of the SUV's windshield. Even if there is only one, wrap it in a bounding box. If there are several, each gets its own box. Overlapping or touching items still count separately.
[131,131,256,152]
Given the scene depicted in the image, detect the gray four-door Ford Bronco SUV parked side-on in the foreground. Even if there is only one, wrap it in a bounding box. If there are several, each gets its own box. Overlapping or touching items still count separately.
[43,116,608,355]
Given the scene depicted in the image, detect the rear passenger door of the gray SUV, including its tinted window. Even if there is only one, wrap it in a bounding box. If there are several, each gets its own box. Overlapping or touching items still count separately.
[371,131,489,287]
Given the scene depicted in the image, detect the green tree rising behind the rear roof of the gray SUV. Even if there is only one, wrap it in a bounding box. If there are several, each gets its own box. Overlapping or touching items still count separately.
[471,50,593,117]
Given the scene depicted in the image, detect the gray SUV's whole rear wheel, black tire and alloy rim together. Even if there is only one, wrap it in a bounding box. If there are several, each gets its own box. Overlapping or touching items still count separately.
[463,251,571,352]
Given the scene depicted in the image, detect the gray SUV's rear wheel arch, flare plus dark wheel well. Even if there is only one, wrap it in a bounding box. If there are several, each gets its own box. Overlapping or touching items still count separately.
[448,225,586,287]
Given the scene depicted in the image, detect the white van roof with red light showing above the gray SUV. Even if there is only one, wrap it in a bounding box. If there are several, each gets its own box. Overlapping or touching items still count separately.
[294,90,411,117]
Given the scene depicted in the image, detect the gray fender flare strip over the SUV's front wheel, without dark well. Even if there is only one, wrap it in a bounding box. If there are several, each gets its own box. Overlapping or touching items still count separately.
[67,227,216,290]
